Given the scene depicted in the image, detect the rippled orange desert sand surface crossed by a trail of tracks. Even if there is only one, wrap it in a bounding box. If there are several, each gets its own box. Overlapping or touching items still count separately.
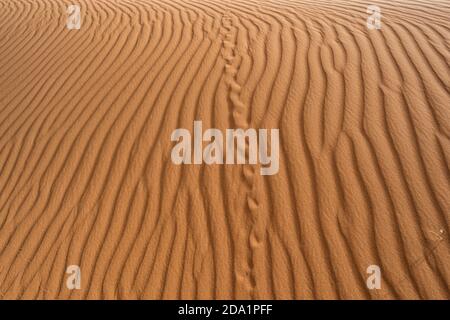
[0,0,450,299]
